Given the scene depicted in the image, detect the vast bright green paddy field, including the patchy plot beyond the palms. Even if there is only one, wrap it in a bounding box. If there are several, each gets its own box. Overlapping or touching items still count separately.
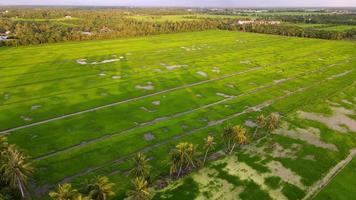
[0,30,356,199]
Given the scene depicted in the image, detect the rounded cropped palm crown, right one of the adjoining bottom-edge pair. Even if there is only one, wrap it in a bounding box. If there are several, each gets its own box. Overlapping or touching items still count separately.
[87,176,115,200]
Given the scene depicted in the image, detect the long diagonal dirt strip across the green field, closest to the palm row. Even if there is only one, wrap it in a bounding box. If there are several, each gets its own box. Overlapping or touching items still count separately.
[54,71,355,183]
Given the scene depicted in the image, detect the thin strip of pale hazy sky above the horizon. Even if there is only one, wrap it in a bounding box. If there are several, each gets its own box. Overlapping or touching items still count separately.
[0,0,356,7]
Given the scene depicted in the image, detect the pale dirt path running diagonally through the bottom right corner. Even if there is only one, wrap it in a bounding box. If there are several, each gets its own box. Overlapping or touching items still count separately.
[303,148,356,200]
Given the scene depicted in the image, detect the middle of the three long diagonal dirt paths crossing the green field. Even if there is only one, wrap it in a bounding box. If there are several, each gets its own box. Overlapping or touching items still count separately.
[32,62,342,160]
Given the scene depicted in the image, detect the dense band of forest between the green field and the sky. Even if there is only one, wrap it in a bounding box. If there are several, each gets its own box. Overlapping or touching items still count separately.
[0,7,356,46]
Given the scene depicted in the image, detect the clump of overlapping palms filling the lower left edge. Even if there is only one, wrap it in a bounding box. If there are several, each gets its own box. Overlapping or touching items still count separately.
[0,135,33,199]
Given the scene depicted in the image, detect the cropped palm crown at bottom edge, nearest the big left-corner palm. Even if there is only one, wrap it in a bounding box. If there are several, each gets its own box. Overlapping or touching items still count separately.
[49,183,78,200]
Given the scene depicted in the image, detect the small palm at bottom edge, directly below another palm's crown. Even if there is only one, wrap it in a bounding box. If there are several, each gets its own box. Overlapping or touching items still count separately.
[127,177,152,200]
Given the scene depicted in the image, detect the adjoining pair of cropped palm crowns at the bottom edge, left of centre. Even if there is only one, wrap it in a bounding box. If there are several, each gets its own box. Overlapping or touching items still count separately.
[49,176,115,200]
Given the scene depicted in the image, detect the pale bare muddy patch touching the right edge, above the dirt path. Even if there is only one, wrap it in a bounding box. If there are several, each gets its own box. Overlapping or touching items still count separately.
[298,107,356,133]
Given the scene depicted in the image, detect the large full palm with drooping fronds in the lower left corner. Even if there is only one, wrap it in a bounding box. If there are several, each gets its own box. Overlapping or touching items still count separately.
[1,145,33,197]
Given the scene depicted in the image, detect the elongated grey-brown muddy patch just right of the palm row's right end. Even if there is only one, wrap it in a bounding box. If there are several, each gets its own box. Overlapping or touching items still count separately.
[274,123,338,151]
